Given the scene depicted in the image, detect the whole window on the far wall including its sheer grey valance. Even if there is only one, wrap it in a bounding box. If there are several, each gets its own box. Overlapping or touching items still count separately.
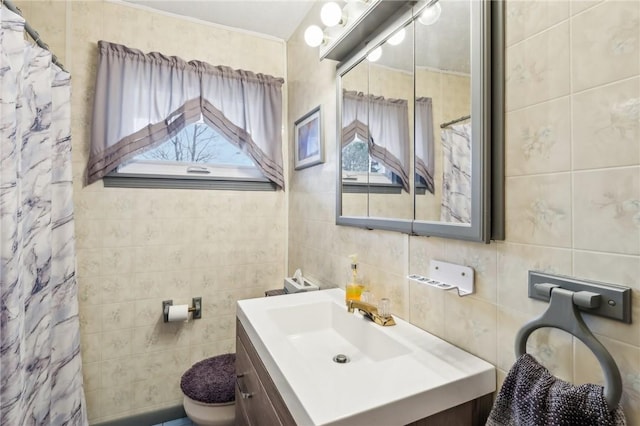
[86,40,284,189]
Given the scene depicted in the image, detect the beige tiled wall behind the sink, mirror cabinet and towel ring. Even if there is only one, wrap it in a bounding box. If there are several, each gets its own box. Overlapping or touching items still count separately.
[287,0,640,424]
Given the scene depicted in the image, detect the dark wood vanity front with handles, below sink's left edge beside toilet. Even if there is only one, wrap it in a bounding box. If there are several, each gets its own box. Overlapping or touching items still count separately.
[235,321,296,426]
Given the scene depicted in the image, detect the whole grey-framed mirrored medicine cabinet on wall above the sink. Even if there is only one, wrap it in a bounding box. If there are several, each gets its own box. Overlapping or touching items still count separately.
[336,0,504,242]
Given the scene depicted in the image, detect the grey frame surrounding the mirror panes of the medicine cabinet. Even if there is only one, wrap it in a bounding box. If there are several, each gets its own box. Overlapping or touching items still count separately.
[336,0,504,243]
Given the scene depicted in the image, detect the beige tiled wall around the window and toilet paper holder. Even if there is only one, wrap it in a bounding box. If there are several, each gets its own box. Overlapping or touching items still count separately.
[18,0,287,424]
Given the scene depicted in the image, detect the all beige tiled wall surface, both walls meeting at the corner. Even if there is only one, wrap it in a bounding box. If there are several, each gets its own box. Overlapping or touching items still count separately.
[19,0,640,424]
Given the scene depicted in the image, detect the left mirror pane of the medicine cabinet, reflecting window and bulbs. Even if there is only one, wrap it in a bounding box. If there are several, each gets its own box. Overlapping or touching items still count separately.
[342,24,413,220]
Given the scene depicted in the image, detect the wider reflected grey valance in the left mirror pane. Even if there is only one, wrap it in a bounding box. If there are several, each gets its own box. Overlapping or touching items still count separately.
[342,90,410,192]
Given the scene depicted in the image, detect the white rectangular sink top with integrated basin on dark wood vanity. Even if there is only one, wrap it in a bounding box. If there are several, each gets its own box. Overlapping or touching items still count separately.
[238,289,496,426]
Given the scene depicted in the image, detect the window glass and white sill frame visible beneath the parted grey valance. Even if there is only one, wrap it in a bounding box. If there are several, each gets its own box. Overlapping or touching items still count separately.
[105,120,272,190]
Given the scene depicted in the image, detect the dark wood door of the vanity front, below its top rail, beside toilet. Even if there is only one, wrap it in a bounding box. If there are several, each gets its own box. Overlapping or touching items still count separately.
[236,338,282,426]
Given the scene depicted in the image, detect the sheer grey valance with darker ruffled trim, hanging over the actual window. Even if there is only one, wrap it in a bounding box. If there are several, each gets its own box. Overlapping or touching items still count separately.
[87,41,284,188]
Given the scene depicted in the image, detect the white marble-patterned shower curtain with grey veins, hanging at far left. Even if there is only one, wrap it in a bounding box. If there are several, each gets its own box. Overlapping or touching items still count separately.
[0,7,88,426]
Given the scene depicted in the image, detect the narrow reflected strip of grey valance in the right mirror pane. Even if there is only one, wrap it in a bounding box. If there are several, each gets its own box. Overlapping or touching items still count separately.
[415,98,435,194]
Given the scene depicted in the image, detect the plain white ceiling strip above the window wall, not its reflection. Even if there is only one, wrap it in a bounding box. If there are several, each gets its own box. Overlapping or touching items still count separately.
[124,0,314,40]
